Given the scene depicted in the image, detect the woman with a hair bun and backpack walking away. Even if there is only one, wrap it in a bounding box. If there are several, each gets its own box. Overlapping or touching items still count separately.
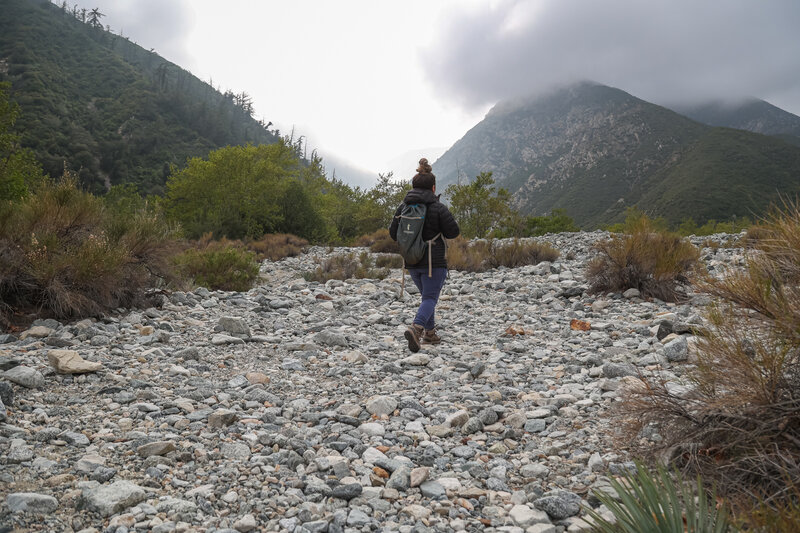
[389,157,460,352]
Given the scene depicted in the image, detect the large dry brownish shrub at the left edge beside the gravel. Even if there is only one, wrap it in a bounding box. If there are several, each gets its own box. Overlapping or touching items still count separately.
[0,173,177,324]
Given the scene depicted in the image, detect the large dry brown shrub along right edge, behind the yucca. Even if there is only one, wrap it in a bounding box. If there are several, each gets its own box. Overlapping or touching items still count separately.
[621,201,800,509]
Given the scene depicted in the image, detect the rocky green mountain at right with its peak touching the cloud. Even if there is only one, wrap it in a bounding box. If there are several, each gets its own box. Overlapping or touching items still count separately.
[434,83,800,228]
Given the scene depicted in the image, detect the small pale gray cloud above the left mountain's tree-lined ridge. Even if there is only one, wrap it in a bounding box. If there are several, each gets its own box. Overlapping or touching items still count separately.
[78,0,194,68]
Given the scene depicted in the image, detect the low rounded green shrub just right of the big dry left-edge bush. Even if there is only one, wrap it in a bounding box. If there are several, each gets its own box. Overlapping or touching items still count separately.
[174,241,259,292]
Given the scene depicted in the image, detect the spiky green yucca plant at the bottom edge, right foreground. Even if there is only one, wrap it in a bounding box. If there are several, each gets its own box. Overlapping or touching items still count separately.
[589,463,732,533]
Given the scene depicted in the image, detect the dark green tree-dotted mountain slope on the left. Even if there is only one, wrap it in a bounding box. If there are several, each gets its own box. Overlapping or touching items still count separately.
[0,0,277,193]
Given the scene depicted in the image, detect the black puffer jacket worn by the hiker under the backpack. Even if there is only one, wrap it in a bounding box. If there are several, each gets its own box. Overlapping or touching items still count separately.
[389,189,461,268]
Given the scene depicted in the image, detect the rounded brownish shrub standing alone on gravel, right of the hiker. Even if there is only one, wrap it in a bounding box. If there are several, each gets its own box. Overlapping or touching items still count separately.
[586,217,700,301]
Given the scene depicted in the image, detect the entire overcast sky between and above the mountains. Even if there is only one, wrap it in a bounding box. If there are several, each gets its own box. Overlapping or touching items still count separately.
[73,0,800,181]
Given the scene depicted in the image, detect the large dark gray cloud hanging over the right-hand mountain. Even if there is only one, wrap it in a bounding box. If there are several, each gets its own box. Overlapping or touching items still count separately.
[423,0,800,114]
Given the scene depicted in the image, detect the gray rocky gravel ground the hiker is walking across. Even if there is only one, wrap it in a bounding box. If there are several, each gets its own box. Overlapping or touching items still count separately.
[0,232,743,533]
